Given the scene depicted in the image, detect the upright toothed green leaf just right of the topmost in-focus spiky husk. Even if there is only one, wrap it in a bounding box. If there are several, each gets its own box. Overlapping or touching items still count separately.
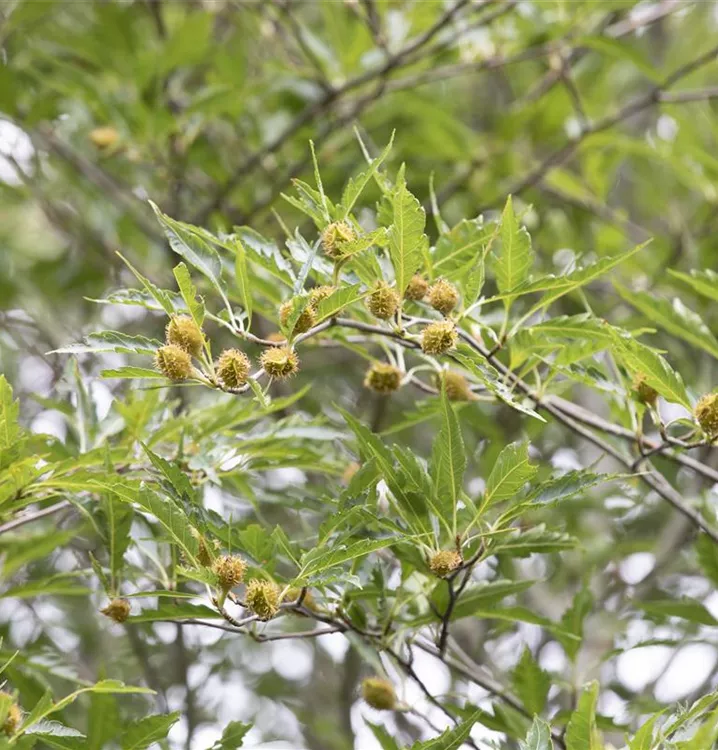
[389,167,427,296]
